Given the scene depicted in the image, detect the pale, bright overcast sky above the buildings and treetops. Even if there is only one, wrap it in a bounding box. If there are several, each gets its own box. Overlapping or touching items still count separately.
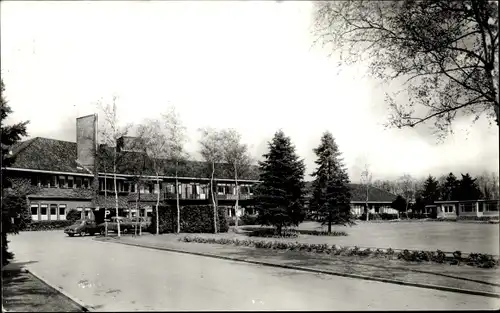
[0,1,499,182]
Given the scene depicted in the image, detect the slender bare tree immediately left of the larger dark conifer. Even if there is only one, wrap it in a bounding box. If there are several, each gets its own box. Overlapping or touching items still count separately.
[222,129,252,227]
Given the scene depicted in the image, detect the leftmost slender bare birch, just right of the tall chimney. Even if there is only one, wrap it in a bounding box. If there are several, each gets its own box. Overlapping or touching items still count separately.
[97,96,131,237]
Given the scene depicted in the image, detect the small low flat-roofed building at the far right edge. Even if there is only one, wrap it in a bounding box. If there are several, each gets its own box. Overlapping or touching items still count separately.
[434,200,500,219]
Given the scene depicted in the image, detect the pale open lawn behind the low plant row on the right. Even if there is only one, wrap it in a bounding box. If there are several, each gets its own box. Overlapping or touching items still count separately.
[243,221,500,255]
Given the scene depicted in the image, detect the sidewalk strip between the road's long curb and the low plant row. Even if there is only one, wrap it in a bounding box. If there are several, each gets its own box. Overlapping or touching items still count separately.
[96,233,500,297]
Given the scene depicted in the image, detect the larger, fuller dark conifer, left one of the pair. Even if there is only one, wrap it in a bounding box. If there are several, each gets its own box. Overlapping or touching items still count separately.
[254,130,305,234]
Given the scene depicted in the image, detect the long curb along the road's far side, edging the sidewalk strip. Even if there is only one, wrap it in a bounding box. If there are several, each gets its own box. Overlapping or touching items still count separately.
[97,240,500,298]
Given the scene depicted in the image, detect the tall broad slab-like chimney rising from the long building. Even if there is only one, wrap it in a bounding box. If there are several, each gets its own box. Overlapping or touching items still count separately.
[76,114,97,172]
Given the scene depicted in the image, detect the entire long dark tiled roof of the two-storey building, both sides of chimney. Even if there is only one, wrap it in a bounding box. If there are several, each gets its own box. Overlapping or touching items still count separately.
[5,137,259,180]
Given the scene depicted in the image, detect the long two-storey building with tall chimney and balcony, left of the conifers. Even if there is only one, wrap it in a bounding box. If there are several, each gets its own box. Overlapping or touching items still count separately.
[2,115,258,221]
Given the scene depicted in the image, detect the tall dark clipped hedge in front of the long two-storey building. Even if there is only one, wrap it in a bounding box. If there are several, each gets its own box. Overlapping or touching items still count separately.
[148,205,229,234]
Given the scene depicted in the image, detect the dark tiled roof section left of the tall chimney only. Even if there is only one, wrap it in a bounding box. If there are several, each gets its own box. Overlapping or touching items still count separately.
[7,137,88,174]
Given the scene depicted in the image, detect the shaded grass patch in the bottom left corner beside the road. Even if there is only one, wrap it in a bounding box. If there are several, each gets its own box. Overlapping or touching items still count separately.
[2,268,84,312]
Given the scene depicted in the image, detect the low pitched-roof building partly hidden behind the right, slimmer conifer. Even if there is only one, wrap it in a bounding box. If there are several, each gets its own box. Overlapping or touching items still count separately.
[306,182,397,216]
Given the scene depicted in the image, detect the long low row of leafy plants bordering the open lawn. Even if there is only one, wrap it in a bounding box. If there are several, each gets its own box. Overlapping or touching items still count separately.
[179,236,499,268]
